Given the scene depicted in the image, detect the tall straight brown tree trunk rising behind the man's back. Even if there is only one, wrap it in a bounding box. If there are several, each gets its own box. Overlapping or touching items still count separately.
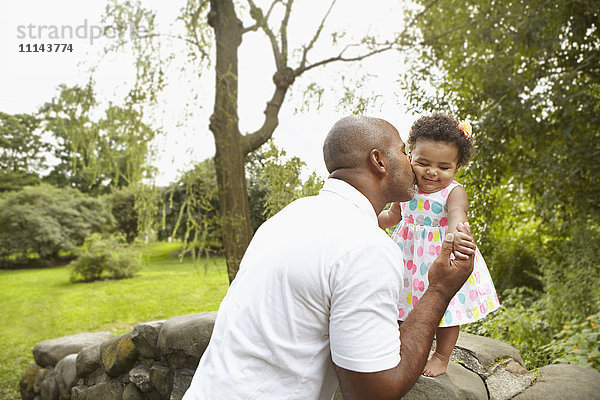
[208,0,252,283]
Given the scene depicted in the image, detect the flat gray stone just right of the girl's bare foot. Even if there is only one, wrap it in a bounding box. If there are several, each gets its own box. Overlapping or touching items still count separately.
[454,332,525,372]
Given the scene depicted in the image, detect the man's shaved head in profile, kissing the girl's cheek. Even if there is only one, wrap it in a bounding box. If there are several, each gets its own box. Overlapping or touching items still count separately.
[323,116,414,205]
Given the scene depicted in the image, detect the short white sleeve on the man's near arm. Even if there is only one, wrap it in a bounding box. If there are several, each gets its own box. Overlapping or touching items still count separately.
[329,245,402,372]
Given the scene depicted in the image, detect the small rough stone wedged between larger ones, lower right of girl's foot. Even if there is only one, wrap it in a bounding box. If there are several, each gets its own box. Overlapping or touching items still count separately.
[485,360,533,400]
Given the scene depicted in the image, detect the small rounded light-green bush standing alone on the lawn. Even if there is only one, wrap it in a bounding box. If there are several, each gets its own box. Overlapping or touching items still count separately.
[71,233,142,282]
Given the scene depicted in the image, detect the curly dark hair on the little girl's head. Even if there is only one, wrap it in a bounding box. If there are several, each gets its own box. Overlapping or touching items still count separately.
[408,112,473,166]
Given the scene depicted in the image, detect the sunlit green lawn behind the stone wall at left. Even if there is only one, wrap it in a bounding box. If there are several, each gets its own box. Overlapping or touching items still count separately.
[0,243,229,399]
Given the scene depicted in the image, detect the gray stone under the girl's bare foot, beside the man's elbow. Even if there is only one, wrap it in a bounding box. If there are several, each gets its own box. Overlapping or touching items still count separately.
[403,362,488,400]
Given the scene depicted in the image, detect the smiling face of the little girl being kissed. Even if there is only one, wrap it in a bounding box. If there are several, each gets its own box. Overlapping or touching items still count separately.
[409,139,459,193]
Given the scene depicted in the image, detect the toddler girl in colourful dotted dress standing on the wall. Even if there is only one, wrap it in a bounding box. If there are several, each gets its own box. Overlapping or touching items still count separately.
[378,113,500,376]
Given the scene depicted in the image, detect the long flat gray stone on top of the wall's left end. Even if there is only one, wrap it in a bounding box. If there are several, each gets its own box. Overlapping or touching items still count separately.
[33,332,113,367]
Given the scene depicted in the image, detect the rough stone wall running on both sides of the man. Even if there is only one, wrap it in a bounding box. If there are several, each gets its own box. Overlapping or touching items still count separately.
[20,312,600,400]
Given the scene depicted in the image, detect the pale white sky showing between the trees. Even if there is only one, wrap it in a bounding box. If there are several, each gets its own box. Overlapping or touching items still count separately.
[0,0,418,185]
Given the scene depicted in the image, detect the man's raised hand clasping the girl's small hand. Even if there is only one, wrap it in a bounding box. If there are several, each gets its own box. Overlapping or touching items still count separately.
[429,223,475,300]
